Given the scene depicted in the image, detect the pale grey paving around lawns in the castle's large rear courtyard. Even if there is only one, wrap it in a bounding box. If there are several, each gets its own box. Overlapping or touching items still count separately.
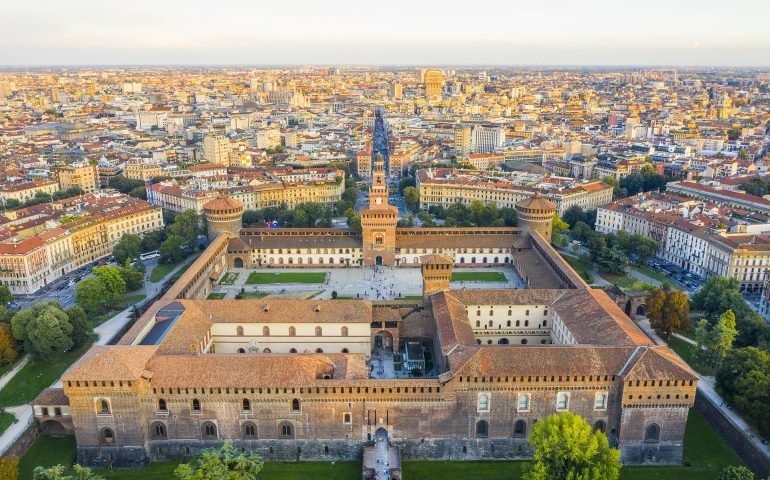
[213,267,526,300]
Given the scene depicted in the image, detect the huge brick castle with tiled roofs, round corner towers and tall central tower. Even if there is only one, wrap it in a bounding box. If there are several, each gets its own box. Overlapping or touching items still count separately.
[34,155,698,472]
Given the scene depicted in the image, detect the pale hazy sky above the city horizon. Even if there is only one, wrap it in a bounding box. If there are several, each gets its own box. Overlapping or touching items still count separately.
[0,0,770,66]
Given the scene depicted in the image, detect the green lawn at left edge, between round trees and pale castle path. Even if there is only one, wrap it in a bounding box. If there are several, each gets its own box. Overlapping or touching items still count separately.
[0,339,93,407]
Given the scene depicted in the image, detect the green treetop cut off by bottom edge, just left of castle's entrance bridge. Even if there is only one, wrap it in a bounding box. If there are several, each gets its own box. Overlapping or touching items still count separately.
[174,441,264,480]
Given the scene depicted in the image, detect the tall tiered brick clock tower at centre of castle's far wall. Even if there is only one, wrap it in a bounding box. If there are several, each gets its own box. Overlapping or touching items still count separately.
[361,155,398,266]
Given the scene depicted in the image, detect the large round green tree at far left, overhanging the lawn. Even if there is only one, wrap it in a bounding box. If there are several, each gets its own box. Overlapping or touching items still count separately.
[11,301,73,359]
